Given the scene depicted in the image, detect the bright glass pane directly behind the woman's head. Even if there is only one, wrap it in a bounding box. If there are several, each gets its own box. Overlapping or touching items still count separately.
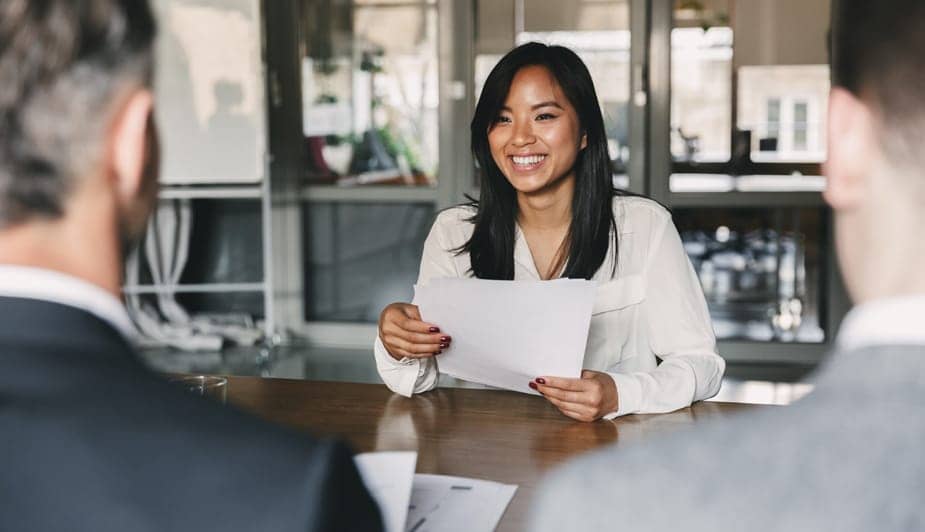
[475,0,630,188]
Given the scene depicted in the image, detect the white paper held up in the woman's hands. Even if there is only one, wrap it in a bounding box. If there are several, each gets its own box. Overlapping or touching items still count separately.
[414,279,597,394]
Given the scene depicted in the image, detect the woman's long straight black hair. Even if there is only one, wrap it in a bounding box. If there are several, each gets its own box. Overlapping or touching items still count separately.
[457,42,624,280]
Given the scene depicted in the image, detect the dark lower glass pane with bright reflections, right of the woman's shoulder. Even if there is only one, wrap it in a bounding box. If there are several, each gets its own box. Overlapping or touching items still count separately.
[674,208,825,342]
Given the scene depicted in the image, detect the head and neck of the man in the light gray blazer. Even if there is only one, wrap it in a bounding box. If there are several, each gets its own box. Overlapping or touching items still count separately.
[825,0,925,302]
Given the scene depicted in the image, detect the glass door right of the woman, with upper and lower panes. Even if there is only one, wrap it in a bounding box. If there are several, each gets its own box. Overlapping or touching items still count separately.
[650,0,844,363]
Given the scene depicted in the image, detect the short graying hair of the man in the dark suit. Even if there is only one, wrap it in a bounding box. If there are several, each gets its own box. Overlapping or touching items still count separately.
[0,0,156,228]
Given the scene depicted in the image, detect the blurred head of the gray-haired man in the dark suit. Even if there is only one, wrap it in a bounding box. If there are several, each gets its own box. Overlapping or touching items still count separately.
[0,0,157,260]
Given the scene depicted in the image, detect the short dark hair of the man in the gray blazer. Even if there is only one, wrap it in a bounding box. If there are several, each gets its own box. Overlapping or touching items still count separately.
[831,0,925,165]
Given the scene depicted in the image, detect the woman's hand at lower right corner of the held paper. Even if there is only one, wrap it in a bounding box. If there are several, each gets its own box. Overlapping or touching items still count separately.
[530,369,620,421]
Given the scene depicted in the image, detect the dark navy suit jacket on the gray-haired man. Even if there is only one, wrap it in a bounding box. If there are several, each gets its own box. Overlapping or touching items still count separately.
[0,297,381,532]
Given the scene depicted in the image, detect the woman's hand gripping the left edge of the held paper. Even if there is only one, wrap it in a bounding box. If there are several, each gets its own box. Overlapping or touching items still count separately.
[379,303,451,360]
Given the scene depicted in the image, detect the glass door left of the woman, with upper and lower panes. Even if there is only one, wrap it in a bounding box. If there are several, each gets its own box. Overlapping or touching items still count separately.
[299,0,447,328]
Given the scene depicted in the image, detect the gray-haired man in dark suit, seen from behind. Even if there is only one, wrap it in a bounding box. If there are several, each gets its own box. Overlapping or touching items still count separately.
[0,0,381,531]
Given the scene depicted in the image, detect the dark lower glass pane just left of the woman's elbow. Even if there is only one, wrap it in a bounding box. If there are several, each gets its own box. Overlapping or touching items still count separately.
[303,203,434,323]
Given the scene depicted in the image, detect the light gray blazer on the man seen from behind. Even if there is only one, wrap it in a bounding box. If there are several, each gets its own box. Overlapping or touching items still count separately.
[531,345,925,532]
